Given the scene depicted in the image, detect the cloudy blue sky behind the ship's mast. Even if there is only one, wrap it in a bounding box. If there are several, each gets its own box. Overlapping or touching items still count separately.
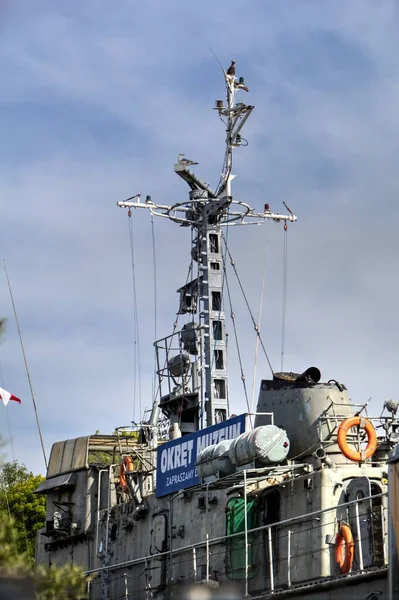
[0,0,399,472]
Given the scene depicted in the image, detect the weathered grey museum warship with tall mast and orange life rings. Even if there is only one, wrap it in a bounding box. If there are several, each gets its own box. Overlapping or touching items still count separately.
[36,62,399,600]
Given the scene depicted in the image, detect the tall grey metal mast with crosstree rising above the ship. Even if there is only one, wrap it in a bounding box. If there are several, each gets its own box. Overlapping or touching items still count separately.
[117,63,297,433]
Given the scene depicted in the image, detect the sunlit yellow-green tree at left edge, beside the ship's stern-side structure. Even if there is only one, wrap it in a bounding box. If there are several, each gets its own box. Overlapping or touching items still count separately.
[0,461,46,560]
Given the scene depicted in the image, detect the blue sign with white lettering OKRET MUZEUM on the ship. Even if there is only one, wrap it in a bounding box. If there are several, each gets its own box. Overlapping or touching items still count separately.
[156,414,246,497]
